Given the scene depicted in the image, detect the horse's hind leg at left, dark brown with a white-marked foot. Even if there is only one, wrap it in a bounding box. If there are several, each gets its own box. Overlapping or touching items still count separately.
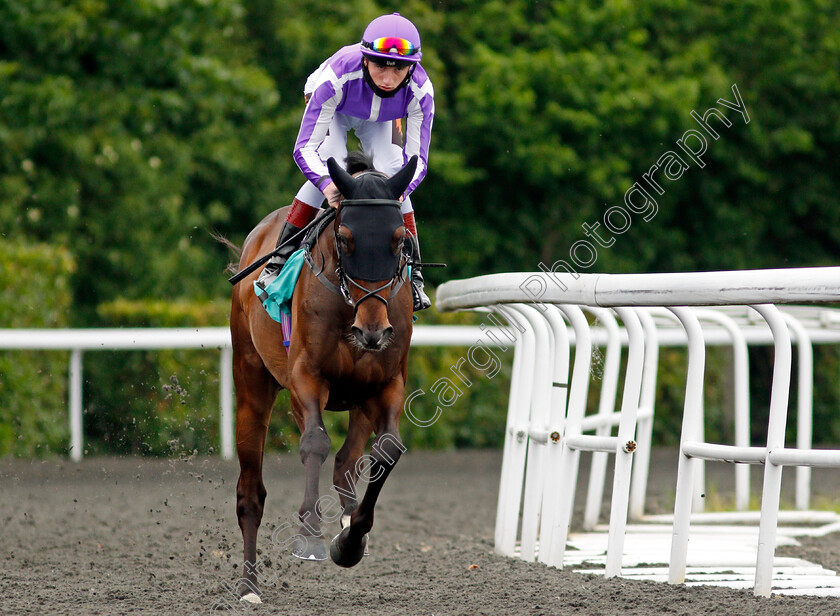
[233,318,279,603]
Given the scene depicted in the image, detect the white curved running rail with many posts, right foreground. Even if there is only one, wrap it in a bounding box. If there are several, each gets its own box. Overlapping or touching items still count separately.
[437,267,840,596]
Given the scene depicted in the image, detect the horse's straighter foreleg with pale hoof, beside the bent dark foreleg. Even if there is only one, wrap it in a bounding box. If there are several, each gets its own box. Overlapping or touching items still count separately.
[291,375,330,560]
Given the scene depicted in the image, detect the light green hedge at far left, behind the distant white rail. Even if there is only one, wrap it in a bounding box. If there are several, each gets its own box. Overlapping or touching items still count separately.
[0,239,75,456]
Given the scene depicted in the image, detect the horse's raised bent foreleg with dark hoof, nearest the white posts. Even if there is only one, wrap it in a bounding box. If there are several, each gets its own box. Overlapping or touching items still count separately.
[330,380,405,567]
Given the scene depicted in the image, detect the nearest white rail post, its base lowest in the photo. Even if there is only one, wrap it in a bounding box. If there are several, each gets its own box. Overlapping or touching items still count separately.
[753,304,793,597]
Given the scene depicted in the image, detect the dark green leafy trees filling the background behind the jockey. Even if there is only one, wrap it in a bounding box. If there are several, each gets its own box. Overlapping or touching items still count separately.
[0,0,840,453]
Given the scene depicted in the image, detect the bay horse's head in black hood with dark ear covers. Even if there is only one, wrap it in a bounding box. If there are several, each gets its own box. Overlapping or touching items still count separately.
[327,156,417,351]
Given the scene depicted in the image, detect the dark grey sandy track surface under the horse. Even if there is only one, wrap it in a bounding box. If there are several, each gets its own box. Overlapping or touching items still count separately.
[0,450,840,616]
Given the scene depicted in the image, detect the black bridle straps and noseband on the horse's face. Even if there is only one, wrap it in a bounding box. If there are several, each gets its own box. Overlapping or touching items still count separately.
[306,188,409,316]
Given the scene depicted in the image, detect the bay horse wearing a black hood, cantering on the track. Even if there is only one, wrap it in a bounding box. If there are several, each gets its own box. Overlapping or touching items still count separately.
[230,153,417,603]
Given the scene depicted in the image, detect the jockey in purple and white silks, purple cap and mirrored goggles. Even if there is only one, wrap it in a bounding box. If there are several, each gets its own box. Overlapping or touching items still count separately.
[257,13,435,310]
